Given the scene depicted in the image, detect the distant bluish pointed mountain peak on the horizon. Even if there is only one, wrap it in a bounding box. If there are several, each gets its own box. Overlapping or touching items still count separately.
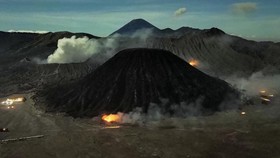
[111,18,160,35]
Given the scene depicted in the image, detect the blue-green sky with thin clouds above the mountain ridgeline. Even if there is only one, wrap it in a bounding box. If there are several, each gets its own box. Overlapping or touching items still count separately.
[0,0,280,41]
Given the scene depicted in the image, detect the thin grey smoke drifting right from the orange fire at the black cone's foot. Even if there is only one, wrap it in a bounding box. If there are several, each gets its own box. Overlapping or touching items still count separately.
[101,97,240,127]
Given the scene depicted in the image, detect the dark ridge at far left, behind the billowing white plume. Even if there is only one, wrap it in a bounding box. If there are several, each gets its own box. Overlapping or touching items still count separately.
[0,31,99,68]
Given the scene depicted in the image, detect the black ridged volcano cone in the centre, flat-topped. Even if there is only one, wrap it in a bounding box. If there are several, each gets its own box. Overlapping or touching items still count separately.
[37,48,237,117]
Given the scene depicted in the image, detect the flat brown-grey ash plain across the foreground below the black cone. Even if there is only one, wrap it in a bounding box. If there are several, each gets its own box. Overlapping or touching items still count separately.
[0,94,280,158]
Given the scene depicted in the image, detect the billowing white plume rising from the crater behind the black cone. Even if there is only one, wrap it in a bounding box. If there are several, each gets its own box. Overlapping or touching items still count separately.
[45,29,153,63]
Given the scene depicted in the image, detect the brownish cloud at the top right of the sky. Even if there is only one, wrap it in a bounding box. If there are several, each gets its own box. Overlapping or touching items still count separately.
[232,2,258,14]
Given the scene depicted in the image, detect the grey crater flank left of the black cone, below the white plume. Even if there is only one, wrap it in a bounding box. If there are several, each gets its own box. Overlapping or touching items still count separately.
[0,62,98,97]
